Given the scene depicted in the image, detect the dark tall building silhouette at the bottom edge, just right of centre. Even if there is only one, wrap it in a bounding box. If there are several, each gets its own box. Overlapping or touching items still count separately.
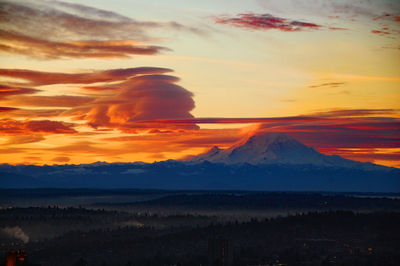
[208,238,233,266]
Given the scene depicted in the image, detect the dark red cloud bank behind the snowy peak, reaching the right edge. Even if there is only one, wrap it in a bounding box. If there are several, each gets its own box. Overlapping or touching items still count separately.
[155,109,400,166]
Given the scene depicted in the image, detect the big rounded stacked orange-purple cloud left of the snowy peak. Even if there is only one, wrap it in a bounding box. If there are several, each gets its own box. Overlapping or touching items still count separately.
[69,75,197,132]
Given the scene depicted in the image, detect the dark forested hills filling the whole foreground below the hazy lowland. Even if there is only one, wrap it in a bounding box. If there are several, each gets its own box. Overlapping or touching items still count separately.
[0,192,400,266]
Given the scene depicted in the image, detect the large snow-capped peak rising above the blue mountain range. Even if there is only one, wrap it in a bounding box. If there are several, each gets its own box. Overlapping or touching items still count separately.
[190,133,371,167]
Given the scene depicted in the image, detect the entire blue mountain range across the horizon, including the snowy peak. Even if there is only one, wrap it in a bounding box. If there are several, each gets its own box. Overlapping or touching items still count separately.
[0,133,400,192]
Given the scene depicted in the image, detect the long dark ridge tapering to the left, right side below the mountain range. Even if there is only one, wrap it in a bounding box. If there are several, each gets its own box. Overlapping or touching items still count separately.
[117,192,400,210]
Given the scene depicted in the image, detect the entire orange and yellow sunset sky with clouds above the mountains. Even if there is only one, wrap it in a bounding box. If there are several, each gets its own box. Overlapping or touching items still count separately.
[0,0,400,167]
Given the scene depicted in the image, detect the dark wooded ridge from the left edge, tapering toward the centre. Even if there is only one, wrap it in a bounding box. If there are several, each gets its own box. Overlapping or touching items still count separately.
[0,205,219,241]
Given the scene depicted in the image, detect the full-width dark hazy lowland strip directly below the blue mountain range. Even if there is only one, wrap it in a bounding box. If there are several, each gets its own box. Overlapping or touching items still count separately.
[0,189,400,211]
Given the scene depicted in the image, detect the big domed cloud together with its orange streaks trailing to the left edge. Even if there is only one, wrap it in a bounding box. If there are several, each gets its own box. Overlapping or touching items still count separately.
[0,67,198,133]
